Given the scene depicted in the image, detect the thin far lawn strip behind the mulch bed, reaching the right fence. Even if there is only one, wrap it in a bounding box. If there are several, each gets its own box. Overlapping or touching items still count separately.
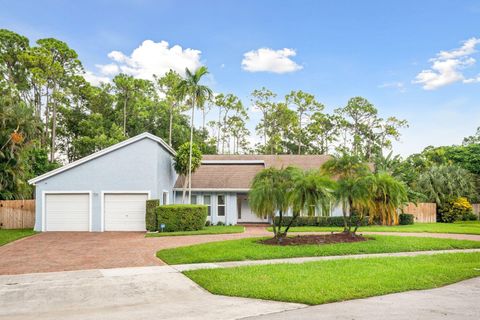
[268,221,480,234]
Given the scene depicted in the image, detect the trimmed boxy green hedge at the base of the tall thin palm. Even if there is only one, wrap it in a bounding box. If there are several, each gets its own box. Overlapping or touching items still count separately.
[155,204,207,232]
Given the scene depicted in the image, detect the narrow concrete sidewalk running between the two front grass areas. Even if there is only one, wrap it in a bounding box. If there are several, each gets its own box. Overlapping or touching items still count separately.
[171,249,480,272]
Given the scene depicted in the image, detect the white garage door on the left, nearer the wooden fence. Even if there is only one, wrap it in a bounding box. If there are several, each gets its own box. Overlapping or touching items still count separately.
[45,193,90,231]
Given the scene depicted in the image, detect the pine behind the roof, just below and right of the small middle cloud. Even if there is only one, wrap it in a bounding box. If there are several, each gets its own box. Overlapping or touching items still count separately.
[285,90,325,154]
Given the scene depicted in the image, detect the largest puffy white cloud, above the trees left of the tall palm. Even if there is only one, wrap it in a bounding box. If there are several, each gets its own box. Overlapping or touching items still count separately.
[85,40,202,83]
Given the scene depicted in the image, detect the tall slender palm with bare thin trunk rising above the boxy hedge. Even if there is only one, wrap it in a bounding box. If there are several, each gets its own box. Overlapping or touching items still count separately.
[177,66,213,203]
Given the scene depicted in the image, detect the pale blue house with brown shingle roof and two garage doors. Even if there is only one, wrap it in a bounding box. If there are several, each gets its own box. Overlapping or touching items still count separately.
[29,133,338,231]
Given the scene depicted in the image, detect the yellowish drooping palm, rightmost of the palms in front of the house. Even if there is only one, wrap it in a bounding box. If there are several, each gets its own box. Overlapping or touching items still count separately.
[364,172,408,225]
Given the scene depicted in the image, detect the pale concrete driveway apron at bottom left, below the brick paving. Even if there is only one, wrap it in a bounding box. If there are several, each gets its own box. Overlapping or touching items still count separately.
[0,266,305,320]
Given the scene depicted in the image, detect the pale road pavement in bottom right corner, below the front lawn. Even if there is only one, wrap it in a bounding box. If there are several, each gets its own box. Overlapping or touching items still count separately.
[243,277,480,320]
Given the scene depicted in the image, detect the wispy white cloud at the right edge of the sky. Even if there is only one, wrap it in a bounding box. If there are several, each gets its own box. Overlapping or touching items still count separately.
[413,38,480,90]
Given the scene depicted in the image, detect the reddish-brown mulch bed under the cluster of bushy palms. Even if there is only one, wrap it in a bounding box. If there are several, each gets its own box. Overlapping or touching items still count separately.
[259,233,369,246]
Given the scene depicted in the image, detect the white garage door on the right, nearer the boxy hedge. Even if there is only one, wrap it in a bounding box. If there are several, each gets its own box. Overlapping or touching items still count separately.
[104,193,148,231]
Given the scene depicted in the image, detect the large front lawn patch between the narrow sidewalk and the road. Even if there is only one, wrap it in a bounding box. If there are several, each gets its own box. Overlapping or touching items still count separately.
[185,253,480,304]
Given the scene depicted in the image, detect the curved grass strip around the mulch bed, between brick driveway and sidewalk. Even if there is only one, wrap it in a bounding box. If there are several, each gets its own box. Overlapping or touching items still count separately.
[157,235,480,264]
